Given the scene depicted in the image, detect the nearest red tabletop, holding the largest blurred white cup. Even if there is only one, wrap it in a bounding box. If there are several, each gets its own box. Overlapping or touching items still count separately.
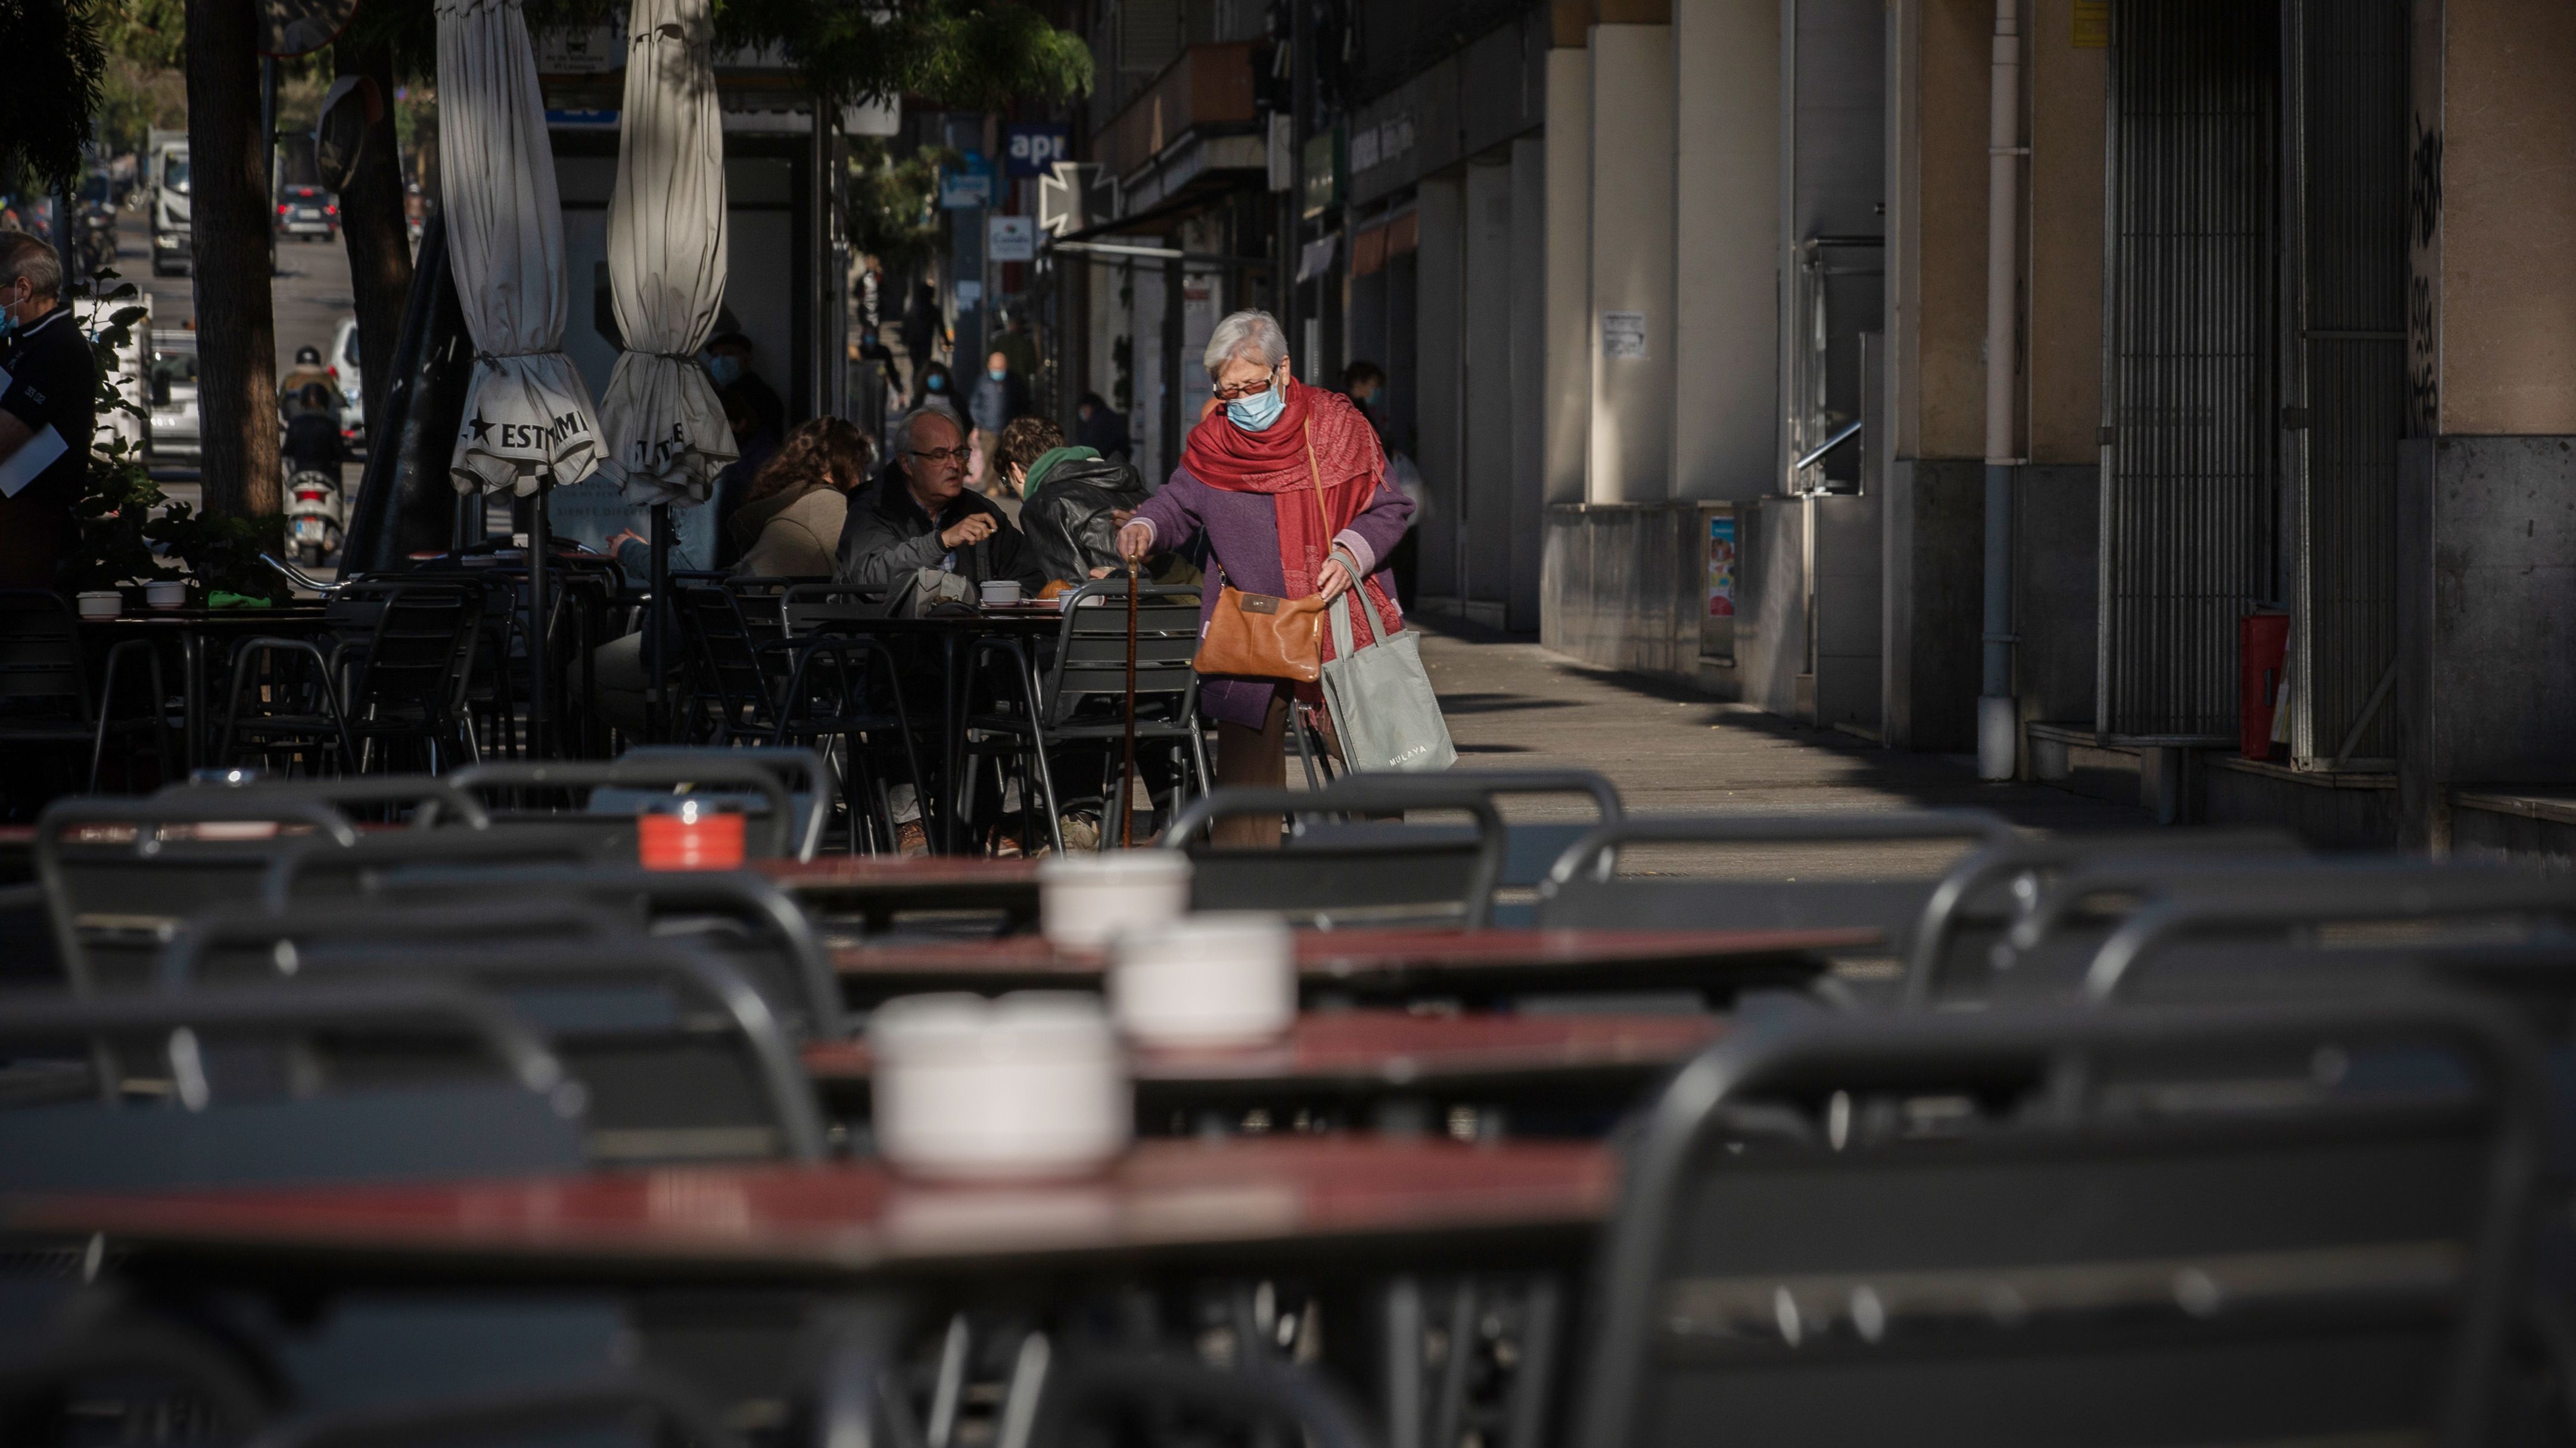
[0,1136,1617,1291]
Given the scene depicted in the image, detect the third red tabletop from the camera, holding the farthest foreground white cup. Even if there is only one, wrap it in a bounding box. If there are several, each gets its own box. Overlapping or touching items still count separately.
[832,930,1878,1007]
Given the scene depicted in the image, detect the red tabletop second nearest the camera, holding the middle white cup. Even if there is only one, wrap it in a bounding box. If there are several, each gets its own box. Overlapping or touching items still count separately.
[804,1010,1728,1129]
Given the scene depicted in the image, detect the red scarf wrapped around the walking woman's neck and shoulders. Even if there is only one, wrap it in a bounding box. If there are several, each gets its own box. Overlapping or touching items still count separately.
[1180,379,1404,659]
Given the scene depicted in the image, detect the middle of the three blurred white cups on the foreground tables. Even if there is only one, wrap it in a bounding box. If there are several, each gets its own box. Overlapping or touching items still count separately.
[1110,910,1296,1046]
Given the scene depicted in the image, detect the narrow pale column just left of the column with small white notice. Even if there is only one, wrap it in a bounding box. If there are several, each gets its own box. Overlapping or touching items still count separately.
[1541,49,1595,502]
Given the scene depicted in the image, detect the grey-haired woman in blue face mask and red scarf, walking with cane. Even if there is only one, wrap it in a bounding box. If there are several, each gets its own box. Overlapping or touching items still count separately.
[1118,312,1414,845]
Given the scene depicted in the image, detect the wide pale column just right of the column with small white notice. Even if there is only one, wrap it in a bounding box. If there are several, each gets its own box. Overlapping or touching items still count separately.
[1672,0,1780,497]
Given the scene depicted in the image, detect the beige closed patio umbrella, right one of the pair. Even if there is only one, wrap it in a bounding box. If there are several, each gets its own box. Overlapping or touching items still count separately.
[600,0,737,729]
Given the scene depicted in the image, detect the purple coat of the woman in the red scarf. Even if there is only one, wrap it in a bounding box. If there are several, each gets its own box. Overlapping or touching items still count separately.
[1136,469,1414,729]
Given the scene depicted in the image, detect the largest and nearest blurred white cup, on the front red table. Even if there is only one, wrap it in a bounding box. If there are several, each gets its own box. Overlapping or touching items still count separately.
[868,992,1136,1180]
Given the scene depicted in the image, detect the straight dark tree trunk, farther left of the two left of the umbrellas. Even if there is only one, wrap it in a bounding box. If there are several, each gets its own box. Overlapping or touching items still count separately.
[188,0,278,518]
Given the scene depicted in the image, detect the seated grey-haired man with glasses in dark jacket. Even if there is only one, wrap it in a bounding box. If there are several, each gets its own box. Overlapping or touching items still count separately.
[832,402,1046,598]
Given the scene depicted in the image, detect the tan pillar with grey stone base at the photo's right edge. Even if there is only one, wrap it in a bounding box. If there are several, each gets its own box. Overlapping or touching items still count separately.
[2395,0,2576,850]
